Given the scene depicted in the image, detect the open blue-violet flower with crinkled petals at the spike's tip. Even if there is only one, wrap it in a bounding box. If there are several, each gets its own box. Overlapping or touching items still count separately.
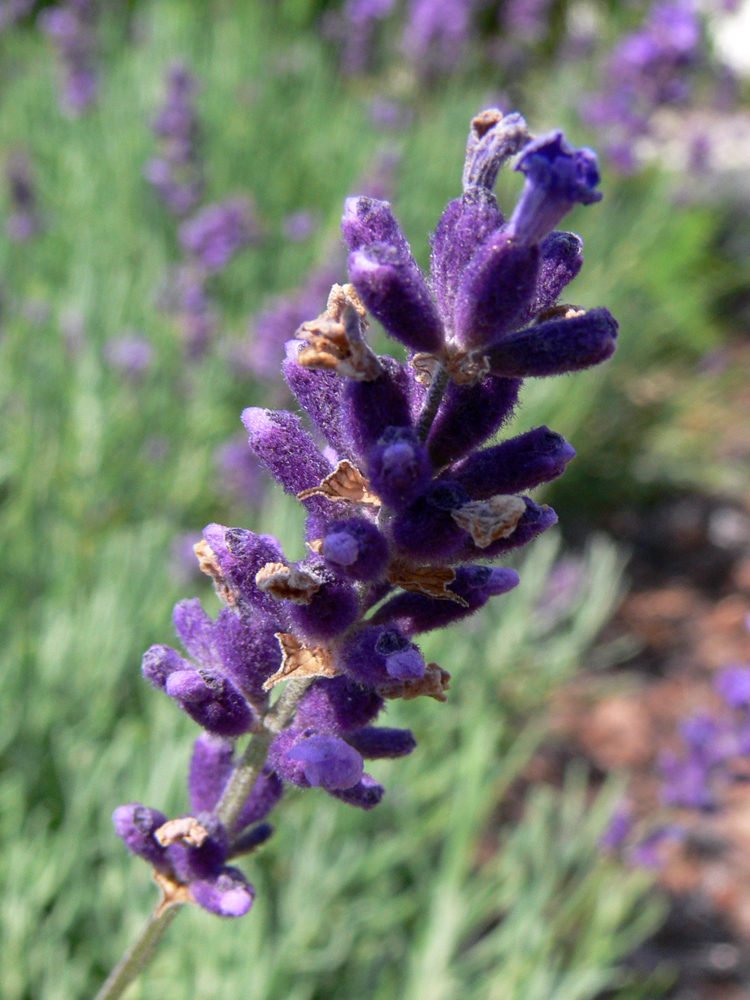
[508,132,602,246]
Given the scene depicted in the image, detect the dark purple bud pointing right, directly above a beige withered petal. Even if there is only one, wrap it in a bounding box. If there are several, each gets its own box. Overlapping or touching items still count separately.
[451,427,575,500]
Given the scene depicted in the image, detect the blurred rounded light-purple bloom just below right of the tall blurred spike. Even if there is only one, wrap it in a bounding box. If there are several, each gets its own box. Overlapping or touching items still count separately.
[180,198,260,271]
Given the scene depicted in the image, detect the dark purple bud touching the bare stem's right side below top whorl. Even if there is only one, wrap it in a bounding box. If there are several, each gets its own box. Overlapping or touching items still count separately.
[427,377,521,469]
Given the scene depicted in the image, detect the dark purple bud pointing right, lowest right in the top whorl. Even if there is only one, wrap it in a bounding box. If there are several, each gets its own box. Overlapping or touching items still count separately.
[487,309,618,376]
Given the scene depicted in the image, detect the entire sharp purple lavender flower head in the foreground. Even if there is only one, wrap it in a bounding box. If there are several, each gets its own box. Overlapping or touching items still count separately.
[115,110,617,916]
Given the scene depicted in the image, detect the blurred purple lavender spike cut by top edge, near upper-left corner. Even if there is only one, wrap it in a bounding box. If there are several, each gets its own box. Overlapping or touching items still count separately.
[40,0,98,115]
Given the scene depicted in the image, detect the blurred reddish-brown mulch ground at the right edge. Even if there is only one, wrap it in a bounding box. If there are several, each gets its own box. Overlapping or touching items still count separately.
[526,488,750,1000]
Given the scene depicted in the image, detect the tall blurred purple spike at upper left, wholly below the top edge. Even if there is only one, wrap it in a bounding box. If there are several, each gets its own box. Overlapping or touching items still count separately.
[144,64,203,215]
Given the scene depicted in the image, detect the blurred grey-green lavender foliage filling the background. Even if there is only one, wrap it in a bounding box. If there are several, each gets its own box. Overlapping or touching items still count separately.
[0,0,750,1000]
